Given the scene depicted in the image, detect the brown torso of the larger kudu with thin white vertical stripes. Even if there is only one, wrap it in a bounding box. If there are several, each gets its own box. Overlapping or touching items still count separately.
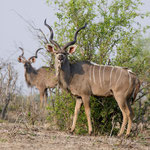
[69,62,140,99]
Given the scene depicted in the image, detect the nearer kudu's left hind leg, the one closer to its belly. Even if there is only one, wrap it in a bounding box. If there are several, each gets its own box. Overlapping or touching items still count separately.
[115,96,128,136]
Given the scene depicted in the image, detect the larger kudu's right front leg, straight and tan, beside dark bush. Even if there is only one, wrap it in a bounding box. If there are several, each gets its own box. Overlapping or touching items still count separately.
[82,96,92,135]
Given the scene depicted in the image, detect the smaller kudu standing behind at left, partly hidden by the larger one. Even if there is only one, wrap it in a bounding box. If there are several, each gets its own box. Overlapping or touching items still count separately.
[18,47,57,107]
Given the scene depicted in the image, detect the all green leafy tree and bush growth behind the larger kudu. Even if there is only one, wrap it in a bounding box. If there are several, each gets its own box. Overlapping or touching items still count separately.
[44,0,149,134]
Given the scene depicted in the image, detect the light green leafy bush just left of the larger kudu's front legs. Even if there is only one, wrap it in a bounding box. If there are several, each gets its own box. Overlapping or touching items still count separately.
[48,92,75,130]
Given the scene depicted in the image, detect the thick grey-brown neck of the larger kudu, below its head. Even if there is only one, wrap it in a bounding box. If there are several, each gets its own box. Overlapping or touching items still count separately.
[56,58,71,90]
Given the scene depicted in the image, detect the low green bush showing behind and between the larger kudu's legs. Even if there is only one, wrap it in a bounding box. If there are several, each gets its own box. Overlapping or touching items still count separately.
[48,92,122,135]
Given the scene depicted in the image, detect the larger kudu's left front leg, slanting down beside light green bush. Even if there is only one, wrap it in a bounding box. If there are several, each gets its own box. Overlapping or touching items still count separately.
[71,99,82,133]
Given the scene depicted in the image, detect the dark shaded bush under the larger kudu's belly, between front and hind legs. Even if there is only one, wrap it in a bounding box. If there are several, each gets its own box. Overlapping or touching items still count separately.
[91,97,122,134]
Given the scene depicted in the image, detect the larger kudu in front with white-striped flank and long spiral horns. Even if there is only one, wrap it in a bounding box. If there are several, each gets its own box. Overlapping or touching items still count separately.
[45,20,140,136]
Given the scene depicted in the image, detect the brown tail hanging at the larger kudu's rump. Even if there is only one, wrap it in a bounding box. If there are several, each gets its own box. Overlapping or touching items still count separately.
[131,78,141,104]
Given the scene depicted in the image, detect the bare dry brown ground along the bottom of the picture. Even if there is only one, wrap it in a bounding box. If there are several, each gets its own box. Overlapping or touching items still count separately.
[0,122,150,150]
